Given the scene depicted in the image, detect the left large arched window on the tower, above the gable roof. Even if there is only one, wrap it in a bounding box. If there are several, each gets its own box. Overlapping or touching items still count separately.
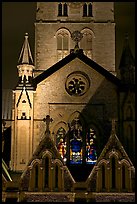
[57,29,69,61]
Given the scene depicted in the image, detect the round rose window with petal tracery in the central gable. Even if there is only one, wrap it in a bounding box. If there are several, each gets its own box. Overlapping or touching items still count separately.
[66,71,90,96]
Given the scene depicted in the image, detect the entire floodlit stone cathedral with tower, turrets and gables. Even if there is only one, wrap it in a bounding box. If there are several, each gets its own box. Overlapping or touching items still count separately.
[2,2,135,202]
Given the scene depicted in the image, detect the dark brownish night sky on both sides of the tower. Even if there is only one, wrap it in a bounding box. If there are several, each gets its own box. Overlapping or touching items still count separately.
[2,2,135,89]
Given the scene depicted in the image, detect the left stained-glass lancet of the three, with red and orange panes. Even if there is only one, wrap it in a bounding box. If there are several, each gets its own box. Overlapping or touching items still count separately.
[56,127,67,162]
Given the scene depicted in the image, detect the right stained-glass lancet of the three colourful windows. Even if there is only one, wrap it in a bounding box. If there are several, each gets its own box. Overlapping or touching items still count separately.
[86,128,97,164]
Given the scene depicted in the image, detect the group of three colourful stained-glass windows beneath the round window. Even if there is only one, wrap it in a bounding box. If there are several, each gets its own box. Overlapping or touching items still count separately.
[56,117,97,165]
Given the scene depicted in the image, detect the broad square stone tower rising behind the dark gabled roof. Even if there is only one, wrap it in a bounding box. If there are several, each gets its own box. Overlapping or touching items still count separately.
[35,2,116,75]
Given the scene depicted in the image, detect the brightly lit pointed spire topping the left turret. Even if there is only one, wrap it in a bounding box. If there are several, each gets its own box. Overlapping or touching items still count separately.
[16,33,34,89]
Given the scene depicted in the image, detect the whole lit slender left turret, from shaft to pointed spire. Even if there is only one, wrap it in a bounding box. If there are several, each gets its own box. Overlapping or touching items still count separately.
[11,33,34,171]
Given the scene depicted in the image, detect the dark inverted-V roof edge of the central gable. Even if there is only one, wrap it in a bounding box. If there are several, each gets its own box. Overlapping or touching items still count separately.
[33,49,120,86]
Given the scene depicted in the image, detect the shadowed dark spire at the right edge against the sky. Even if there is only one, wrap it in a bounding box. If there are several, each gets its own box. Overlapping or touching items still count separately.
[119,33,135,84]
